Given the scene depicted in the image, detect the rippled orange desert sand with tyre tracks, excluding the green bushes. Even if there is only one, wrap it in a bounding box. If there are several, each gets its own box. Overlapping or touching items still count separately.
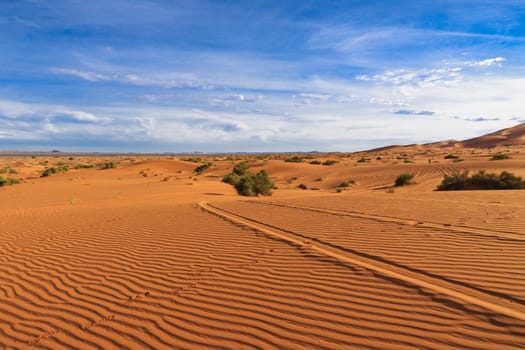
[0,133,525,349]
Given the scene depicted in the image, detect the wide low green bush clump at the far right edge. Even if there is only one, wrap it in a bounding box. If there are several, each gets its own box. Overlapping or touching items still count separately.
[437,170,525,191]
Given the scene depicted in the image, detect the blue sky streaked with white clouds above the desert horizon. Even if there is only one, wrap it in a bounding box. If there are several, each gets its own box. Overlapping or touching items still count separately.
[0,0,525,152]
